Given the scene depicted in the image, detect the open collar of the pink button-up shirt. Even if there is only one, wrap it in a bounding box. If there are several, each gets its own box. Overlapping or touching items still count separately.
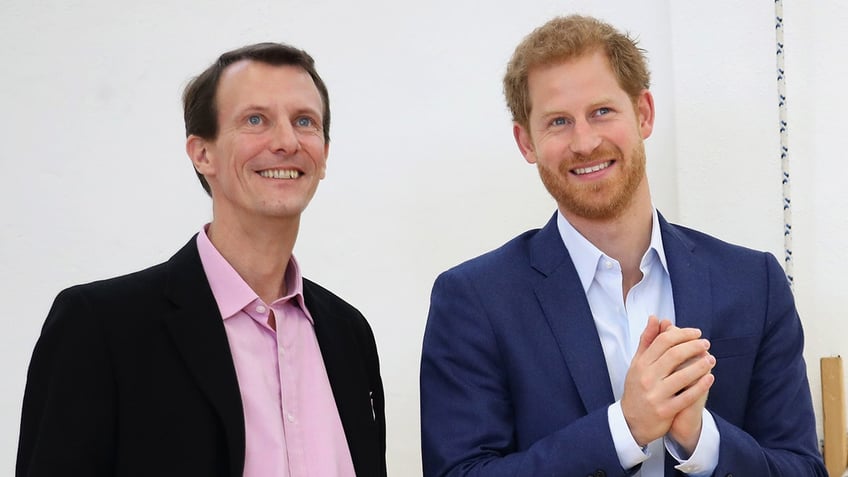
[197,224,314,324]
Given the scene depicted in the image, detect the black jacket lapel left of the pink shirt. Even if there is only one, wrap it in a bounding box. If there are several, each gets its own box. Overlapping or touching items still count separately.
[165,238,245,476]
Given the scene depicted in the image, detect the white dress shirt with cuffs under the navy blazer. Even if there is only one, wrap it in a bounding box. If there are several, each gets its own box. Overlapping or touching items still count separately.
[557,209,719,477]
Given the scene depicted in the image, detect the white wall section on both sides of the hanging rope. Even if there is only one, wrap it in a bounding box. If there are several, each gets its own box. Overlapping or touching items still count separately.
[669,0,848,446]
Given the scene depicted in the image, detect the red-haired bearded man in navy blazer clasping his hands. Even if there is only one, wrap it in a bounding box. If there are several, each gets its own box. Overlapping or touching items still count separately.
[421,15,826,477]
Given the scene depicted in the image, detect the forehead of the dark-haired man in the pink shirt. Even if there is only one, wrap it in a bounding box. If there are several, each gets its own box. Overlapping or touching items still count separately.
[215,60,323,114]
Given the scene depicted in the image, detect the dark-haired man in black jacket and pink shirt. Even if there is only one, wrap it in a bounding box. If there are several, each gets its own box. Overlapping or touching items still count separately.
[16,43,386,477]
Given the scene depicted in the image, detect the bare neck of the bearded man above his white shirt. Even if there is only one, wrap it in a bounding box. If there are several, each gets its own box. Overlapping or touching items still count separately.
[560,181,653,298]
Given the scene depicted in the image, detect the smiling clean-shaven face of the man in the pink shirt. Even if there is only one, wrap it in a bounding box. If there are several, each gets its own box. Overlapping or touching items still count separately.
[186,60,329,227]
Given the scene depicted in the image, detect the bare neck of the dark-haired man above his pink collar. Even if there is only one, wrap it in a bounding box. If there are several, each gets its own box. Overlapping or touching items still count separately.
[207,213,300,303]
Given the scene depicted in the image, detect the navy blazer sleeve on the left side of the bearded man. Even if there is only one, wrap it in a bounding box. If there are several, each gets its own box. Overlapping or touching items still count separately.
[420,269,628,477]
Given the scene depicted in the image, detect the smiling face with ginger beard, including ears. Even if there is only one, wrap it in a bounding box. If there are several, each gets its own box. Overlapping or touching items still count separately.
[513,51,654,220]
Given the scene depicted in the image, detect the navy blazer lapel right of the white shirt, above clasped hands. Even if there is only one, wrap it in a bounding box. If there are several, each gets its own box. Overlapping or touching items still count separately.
[659,215,713,338]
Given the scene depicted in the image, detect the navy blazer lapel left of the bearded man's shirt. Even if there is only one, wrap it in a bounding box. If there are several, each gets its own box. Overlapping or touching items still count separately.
[530,214,615,412]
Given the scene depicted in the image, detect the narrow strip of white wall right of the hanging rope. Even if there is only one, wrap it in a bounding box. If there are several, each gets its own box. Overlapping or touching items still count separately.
[784,0,848,442]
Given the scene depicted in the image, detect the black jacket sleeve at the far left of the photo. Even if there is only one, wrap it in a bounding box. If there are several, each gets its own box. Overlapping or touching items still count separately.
[15,289,119,477]
